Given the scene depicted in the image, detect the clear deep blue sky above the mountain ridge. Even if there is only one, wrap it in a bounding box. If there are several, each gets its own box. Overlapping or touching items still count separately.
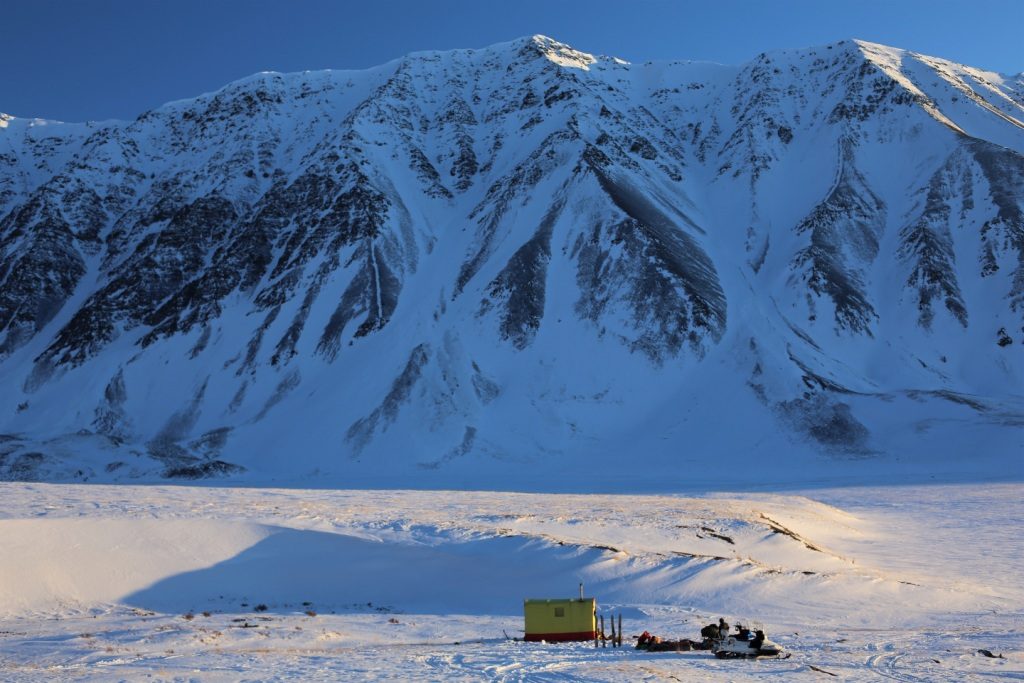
[8,0,1024,121]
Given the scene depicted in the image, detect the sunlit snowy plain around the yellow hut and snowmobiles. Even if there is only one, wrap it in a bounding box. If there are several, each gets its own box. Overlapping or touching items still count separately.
[0,483,1024,681]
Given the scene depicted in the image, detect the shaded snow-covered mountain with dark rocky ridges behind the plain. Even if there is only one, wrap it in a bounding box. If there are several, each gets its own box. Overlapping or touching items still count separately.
[0,36,1024,488]
